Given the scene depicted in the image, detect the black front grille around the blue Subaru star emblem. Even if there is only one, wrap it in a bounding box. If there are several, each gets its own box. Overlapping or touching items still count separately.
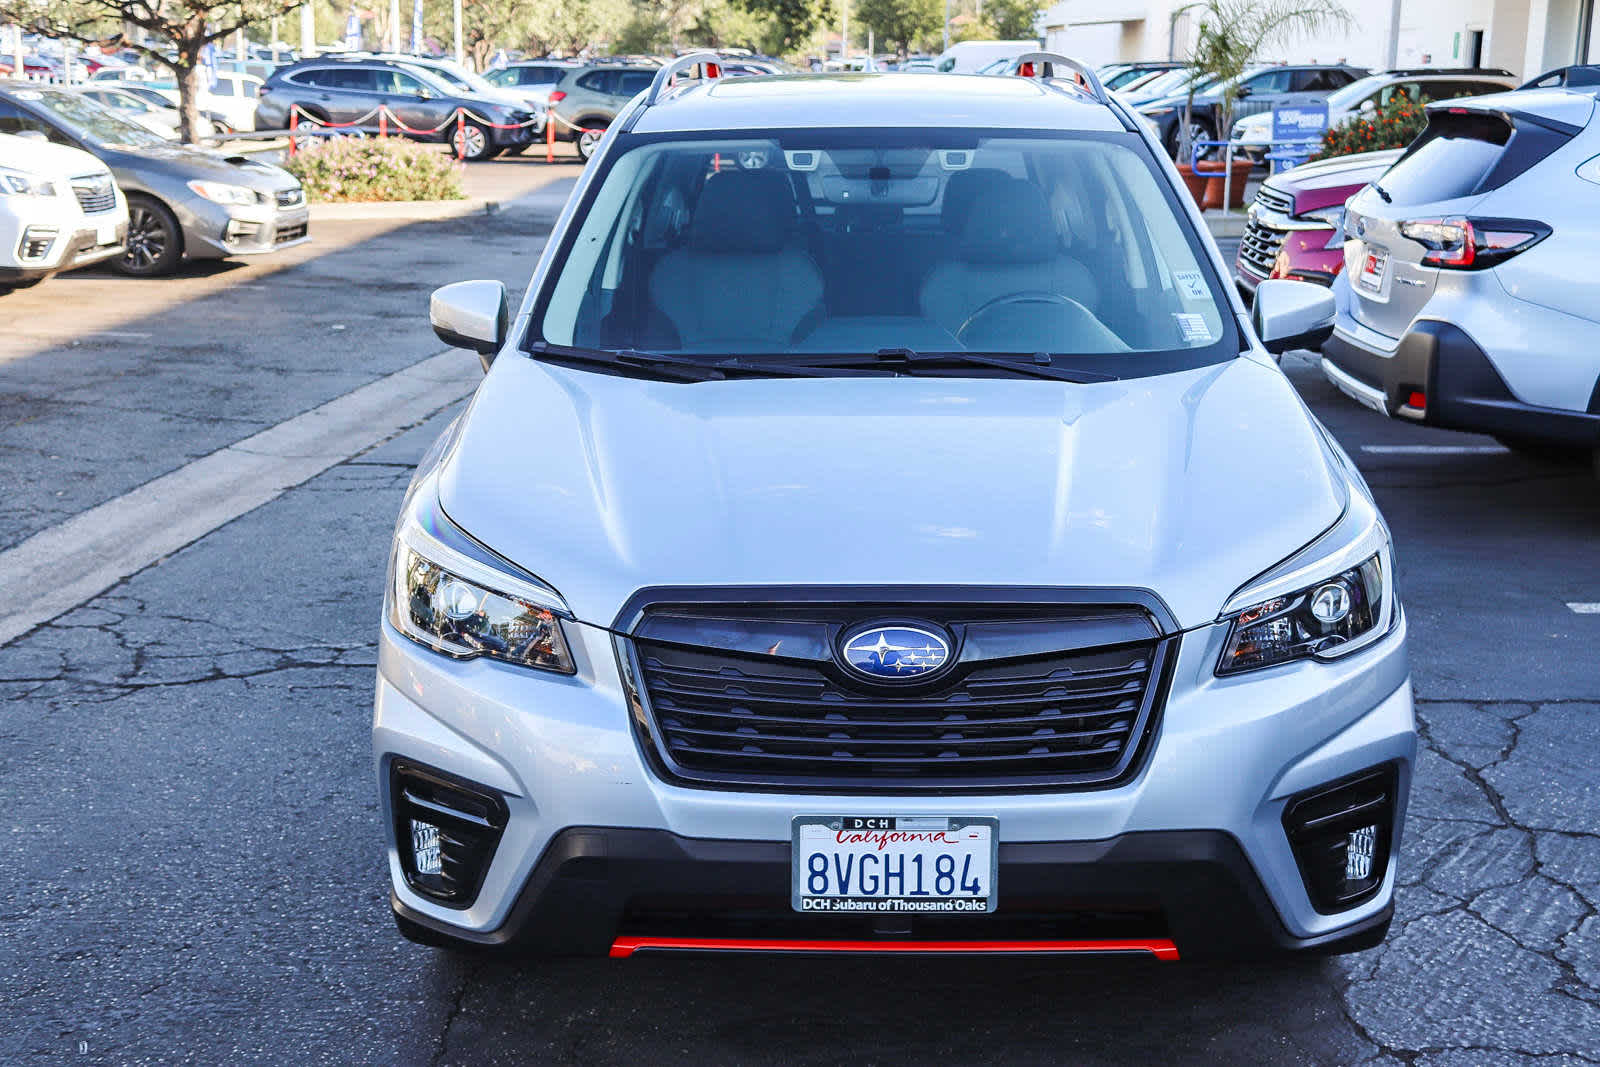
[624,605,1170,792]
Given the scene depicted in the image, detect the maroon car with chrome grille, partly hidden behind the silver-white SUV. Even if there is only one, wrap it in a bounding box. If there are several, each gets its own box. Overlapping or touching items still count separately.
[1234,149,1402,293]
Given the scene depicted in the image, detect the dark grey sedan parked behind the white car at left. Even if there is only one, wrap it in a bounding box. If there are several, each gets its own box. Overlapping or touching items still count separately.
[0,82,309,275]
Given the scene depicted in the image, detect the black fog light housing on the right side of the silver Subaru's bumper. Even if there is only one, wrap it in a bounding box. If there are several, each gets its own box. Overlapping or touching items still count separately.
[1283,765,1398,915]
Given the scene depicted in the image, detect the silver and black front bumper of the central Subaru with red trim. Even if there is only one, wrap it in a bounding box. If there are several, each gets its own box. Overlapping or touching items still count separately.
[373,601,1416,955]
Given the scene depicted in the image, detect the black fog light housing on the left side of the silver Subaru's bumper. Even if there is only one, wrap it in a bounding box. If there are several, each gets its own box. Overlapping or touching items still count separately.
[389,760,506,907]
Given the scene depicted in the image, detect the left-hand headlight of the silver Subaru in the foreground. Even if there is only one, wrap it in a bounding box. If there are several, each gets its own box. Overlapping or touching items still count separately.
[389,490,576,673]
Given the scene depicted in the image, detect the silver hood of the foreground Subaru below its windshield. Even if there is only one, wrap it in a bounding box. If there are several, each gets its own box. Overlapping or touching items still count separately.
[438,355,1349,627]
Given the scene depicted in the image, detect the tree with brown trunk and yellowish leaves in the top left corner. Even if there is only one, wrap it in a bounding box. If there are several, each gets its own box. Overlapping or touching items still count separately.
[0,0,304,141]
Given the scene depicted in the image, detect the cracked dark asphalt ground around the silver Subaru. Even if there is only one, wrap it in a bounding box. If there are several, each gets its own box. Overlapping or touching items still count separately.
[0,187,1600,1067]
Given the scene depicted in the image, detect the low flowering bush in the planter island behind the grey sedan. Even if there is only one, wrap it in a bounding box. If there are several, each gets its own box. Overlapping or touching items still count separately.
[286,138,467,203]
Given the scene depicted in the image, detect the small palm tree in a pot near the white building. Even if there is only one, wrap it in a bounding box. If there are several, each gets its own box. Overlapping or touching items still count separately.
[1178,0,1352,162]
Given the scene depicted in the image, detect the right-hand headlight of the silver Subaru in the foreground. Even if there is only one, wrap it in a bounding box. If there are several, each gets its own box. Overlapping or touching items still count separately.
[1216,491,1397,675]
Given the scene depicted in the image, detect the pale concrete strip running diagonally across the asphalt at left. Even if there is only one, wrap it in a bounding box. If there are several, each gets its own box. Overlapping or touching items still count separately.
[0,350,483,645]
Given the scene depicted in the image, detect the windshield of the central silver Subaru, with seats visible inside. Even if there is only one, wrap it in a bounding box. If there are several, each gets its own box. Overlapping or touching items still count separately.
[531,130,1238,378]
